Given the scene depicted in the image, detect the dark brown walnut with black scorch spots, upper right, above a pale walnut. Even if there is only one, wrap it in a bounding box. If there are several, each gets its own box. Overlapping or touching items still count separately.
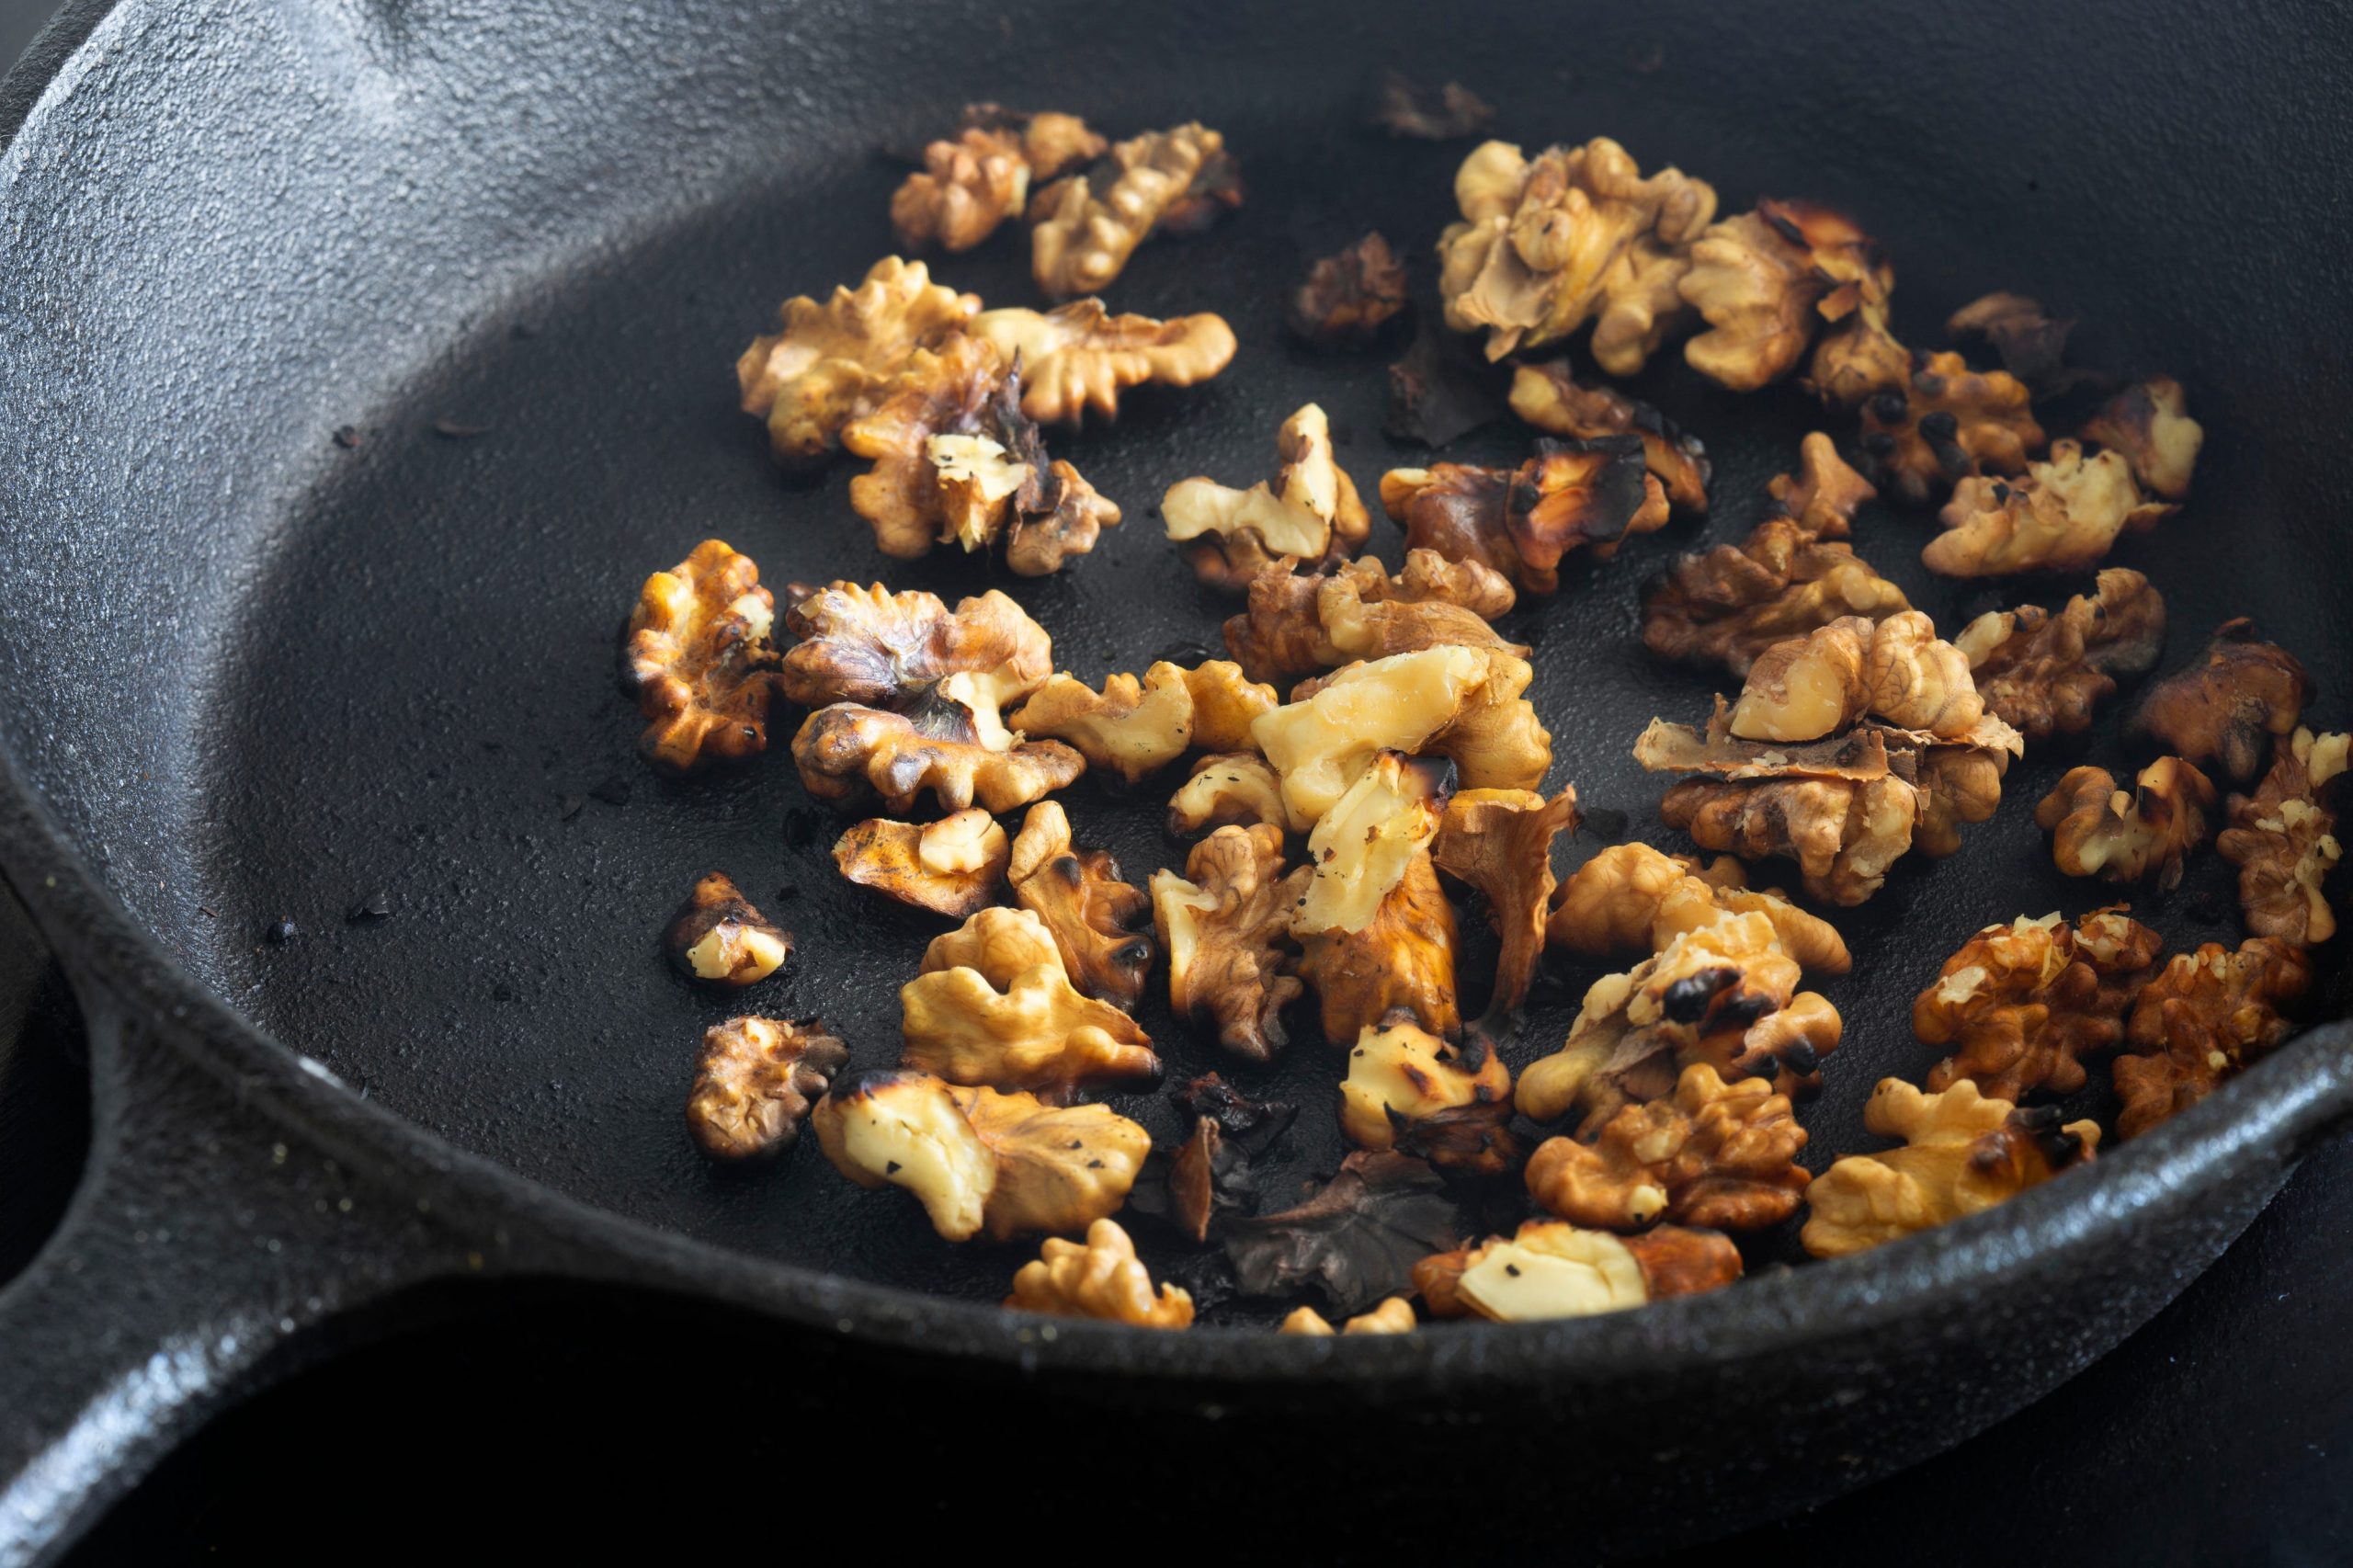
[1859,353,2042,504]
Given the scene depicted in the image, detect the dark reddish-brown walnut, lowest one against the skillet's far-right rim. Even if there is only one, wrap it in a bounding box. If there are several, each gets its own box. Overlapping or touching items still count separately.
[2113,937,2313,1137]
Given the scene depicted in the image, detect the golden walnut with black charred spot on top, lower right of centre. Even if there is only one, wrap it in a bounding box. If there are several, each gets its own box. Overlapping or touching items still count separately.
[1518,911,1840,1132]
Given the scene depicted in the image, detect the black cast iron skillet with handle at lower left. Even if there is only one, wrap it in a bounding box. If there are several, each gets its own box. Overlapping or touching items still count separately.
[0,0,2353,1563]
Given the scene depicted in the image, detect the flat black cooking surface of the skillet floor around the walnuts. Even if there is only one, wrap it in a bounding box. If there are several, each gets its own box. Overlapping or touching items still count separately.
[178,97,2353,1297]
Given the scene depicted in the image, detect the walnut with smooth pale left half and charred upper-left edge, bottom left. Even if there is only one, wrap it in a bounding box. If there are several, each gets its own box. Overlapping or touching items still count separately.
[810,1069,1153,1241]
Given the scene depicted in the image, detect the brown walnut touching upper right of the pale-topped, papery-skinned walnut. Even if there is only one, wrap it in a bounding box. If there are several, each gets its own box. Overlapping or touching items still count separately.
[1953,567,2165,742]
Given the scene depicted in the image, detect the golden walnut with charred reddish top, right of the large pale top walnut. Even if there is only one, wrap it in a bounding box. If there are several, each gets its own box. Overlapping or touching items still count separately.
[1677,198,1894,391]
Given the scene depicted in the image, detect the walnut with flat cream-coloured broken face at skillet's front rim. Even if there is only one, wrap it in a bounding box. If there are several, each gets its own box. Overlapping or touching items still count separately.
[1415,1220,1741,1324]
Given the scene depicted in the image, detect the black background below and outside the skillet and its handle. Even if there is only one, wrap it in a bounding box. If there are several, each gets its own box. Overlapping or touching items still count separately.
[0,0,2353,1563]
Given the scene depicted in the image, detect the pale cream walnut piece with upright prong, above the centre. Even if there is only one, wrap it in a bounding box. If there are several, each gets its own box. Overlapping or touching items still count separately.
[1160,403,1371,588]
